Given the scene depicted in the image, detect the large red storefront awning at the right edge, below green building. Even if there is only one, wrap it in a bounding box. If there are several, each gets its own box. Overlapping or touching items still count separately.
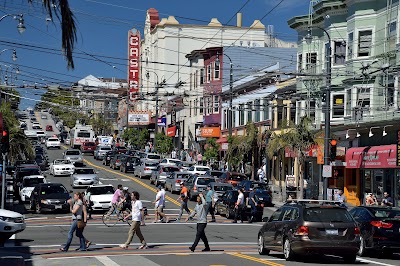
[346,144,398,168]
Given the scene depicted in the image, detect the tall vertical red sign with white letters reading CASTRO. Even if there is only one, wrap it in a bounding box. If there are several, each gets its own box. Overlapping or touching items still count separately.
[128,29,140,104]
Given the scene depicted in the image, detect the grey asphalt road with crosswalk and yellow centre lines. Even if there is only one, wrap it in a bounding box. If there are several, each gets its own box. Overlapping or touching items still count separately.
[0,112,400,266]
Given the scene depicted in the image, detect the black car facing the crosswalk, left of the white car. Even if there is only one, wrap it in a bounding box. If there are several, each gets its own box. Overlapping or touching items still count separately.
[30,183,72,213]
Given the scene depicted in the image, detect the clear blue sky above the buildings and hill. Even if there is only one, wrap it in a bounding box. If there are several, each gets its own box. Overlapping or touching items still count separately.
[0,0,309,108]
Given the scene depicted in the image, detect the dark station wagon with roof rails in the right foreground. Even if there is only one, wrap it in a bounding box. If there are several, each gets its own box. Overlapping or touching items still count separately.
[257,201,360,263]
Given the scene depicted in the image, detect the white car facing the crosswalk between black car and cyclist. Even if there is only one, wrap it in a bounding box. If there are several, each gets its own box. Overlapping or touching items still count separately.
[86,185,115,210]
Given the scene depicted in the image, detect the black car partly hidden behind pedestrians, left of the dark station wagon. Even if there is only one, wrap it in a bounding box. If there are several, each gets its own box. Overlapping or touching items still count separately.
[215,190,264,221]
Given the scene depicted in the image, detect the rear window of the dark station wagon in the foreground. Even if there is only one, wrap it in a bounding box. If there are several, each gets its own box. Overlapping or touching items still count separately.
[303,207,353,223]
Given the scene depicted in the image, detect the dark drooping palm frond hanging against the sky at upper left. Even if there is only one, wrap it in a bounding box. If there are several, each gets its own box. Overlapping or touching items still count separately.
[28,0,77,69]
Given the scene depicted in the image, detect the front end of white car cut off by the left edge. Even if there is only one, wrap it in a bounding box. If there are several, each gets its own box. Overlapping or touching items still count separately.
[0,209,26,239]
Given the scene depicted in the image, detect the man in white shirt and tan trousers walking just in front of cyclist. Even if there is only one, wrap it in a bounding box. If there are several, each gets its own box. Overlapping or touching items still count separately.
[119,191,147,249]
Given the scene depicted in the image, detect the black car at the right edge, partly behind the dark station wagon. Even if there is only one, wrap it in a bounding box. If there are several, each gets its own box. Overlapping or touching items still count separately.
[350,206,400,256]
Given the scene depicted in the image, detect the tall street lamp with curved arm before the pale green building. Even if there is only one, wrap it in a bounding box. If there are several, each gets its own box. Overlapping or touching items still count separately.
[305,26,332,200]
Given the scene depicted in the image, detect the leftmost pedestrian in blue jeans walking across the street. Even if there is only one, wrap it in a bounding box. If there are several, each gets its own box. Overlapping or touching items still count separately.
[60,192,87,251]
